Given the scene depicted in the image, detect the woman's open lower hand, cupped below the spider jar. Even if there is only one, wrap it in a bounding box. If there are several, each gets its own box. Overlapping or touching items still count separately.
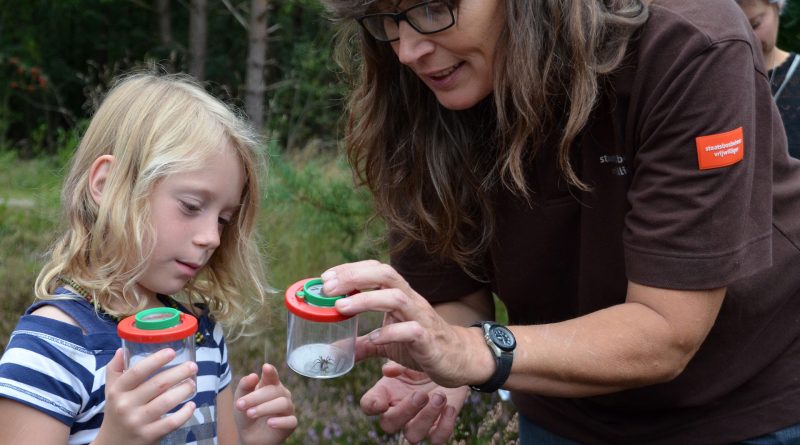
[361,361,469,444]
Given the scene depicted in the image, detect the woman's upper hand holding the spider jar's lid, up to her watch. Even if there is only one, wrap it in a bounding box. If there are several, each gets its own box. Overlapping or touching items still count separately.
[322,261,494,388]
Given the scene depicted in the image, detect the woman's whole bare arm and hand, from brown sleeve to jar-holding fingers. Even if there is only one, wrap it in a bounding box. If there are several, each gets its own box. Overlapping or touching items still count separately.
[325,262,725,397]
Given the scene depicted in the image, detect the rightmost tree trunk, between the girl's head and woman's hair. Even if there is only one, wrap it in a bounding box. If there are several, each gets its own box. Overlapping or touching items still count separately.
[244,0,269,132]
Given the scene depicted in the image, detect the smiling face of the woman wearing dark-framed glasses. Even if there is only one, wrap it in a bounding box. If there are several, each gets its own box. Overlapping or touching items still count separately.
[386,0,504,110]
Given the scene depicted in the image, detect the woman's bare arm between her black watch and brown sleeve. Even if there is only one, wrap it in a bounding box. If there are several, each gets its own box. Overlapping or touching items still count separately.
[500,283,725,397]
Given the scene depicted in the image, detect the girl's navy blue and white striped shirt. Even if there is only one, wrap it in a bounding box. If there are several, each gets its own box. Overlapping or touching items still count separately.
[0,289,231,445]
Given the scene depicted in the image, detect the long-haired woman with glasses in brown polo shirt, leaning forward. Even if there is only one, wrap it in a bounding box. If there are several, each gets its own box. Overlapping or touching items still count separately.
[321,0,800,445]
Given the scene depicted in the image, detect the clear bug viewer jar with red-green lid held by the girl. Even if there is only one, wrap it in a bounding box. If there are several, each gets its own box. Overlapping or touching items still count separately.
[117,307,197,390]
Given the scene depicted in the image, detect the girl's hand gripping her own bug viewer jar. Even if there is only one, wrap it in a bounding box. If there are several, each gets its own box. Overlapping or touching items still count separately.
[93,349,197,445]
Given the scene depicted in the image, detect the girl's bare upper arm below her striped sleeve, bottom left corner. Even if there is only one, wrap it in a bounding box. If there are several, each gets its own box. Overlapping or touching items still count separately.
[0,398,69,444]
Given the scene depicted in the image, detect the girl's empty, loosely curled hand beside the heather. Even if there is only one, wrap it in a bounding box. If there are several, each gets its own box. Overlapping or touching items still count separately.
[234,363,297,444]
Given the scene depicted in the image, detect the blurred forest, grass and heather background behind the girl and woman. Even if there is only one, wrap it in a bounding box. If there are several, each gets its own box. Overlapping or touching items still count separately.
[0,0,800,444]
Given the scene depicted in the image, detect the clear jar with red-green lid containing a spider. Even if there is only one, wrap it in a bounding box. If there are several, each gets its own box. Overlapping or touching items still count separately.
[285,278,358,379]
